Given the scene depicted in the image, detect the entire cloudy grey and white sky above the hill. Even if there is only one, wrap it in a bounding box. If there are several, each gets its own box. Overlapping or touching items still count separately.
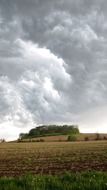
[0,0,107,140]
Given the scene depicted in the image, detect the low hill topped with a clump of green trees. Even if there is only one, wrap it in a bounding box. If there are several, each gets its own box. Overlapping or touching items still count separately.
[18,125,107,142]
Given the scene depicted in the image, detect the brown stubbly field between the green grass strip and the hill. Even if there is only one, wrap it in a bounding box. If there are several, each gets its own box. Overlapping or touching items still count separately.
[0,141,107,176]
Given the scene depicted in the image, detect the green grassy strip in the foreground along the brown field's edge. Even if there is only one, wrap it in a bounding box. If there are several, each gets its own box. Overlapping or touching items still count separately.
[0,172,107,190]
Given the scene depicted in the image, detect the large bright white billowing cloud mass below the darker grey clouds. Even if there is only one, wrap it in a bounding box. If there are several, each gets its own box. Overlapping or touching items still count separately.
[0,39,72,140]
